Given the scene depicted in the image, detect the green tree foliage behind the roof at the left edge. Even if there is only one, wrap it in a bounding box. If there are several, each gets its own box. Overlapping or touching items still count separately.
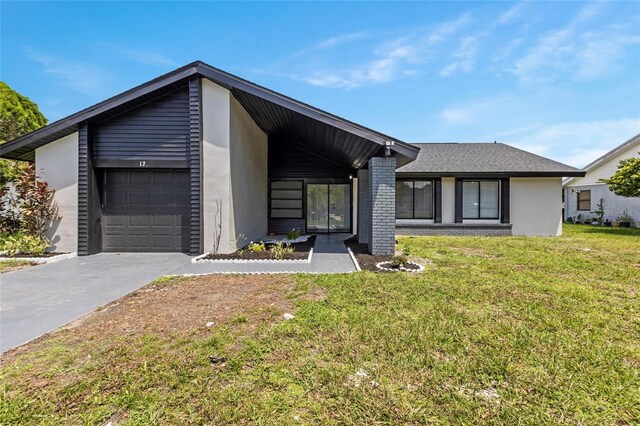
[0,81,47,185]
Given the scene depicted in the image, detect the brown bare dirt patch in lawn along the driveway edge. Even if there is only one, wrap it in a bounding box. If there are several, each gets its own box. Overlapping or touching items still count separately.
[0,275,304,363]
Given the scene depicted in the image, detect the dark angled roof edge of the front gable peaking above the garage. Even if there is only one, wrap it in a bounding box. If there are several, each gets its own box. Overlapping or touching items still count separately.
[0,61,420,160]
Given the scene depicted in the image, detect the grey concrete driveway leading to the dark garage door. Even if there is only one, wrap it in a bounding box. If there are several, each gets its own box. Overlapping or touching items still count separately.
[0,253,191,352]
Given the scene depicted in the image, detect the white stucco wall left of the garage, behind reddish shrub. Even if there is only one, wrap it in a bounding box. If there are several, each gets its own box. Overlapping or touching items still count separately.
[36,132,78,252]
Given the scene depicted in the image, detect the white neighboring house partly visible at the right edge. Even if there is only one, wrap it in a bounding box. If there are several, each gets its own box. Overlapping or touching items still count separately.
[563,134,640,227]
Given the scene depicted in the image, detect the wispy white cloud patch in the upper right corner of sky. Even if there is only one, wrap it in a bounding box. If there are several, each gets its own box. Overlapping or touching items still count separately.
[511,3,640,84]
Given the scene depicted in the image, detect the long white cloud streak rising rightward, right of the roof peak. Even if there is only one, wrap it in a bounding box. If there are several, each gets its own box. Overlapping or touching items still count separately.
[301,14,469,89]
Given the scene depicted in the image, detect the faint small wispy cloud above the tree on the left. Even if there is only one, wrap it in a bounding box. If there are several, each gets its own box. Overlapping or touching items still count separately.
[26,49,111,97]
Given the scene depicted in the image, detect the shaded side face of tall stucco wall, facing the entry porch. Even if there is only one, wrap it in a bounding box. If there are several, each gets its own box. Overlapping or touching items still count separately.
[230,96,269,250]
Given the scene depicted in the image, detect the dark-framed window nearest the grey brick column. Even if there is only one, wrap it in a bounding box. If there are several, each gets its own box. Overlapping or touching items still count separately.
[396,180,433,219]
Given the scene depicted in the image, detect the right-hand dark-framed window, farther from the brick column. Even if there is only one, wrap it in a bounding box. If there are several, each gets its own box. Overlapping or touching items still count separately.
[462,180,500,219]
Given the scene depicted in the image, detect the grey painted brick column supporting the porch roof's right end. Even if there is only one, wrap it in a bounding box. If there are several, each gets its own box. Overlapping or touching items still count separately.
[369,157,396,255]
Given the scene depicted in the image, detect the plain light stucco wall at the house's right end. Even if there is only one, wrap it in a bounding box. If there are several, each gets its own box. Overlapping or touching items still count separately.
[510,177,562,236]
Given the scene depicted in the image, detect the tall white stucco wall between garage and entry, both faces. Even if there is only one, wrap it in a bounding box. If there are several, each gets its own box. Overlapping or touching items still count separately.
[202,79,268,253]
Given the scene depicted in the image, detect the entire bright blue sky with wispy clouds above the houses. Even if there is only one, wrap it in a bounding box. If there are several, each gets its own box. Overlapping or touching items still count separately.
[0,1,640,166]
